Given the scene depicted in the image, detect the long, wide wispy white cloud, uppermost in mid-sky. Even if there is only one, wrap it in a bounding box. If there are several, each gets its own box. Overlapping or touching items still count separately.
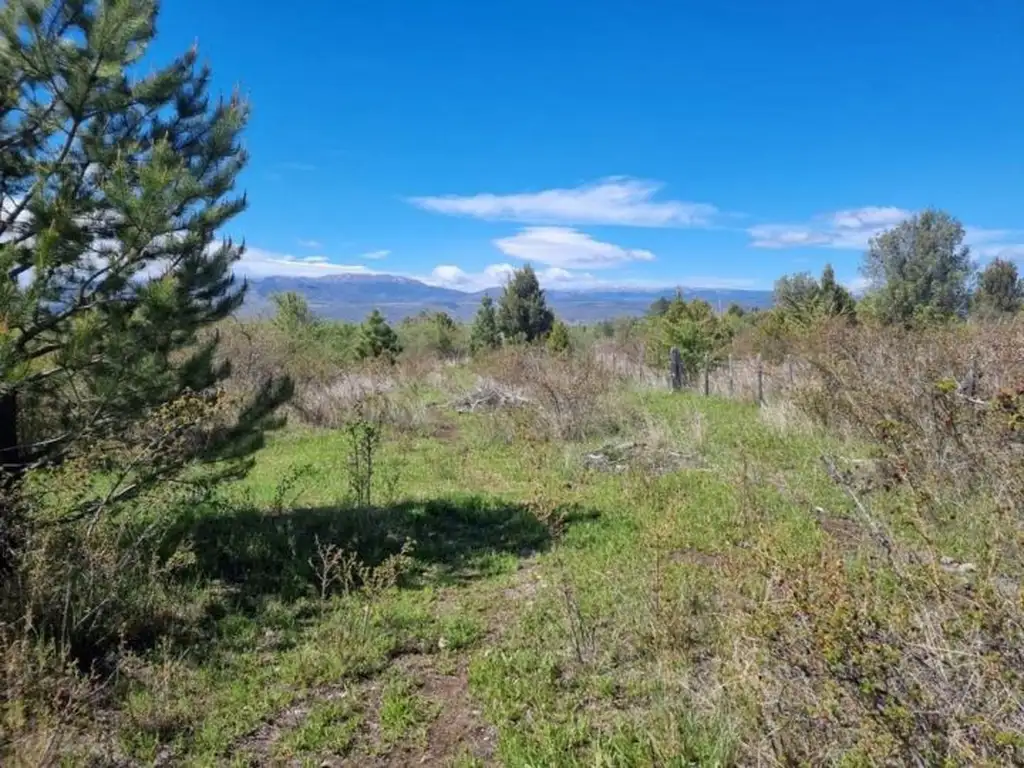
[410,176,718,226]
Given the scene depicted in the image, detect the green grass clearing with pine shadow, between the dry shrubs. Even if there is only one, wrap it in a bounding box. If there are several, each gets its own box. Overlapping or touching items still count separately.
[16,393,1024,766]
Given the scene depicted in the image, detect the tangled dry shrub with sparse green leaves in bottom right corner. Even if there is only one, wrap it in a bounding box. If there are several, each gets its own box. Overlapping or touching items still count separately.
[729,549,1024,765]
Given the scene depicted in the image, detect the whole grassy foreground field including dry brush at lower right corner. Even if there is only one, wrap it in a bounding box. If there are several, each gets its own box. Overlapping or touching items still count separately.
[16,364,1024,766]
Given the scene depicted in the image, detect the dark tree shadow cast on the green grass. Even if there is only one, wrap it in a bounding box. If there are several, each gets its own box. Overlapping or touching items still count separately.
[173,497,595,609]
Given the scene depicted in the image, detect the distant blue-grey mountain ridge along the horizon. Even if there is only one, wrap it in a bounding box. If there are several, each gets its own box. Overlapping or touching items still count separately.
[243,274,772,323]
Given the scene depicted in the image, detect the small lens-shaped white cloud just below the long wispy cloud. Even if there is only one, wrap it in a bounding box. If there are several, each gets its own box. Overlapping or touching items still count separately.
[495,226,654,269]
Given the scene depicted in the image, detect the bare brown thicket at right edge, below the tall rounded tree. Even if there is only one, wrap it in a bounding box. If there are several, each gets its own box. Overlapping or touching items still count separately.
[795,323,1024,520]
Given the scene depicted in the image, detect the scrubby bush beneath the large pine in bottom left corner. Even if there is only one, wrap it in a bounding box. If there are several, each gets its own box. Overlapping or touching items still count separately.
[0,481,202,765]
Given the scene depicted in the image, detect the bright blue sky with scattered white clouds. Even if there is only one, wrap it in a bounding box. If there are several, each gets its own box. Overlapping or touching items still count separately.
[152,0,1024,289]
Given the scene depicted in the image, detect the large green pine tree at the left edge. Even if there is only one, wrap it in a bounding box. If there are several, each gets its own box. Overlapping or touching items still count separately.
[0,0,290,540]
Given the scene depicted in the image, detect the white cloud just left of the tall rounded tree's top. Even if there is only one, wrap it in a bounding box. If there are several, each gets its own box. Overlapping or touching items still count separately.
[746,206,913,250]
